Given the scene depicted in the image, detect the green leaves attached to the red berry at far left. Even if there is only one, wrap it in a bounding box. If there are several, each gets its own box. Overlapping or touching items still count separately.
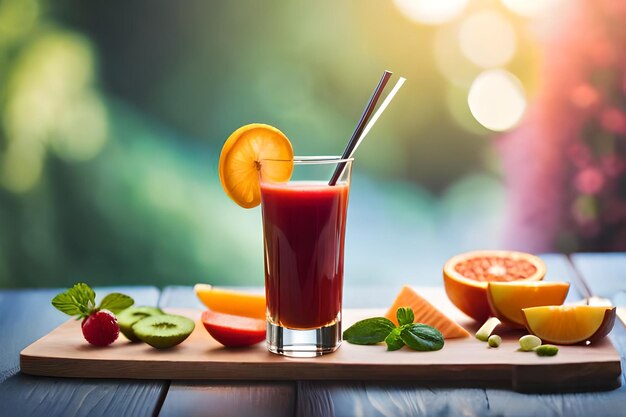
[52,282,135,320]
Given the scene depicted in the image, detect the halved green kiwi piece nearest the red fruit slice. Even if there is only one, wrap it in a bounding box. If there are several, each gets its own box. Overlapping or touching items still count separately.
[132,314,196,349]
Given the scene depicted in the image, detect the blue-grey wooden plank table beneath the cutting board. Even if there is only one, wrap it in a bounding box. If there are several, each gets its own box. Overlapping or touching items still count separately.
[0,253,626,417]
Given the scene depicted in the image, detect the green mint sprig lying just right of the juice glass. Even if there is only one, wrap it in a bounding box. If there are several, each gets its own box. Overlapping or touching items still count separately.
[343,307,444,352]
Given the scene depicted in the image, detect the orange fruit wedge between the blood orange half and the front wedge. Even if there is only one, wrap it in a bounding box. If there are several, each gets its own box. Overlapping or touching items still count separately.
[487,281,569,327]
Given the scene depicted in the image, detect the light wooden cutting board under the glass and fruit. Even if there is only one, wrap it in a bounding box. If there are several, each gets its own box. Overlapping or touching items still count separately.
[20,291,621,392]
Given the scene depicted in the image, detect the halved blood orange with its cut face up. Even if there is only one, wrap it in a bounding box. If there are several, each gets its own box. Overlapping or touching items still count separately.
[443,250,546,322]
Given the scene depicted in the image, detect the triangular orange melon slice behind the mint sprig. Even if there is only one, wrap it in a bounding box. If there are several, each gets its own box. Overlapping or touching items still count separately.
[385,285,470,339]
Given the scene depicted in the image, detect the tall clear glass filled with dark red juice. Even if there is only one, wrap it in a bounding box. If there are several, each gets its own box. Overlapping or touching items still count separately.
[261,156,352,357]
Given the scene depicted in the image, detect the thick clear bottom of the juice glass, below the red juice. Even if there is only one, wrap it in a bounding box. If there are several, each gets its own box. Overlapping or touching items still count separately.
[267,320,341,358]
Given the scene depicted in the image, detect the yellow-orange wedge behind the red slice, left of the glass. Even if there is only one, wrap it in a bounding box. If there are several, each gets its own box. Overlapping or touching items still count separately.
[193,284,265,320]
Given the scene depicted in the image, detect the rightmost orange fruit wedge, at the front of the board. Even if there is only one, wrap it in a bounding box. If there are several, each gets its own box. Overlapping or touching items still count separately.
[522,305,615,345]
